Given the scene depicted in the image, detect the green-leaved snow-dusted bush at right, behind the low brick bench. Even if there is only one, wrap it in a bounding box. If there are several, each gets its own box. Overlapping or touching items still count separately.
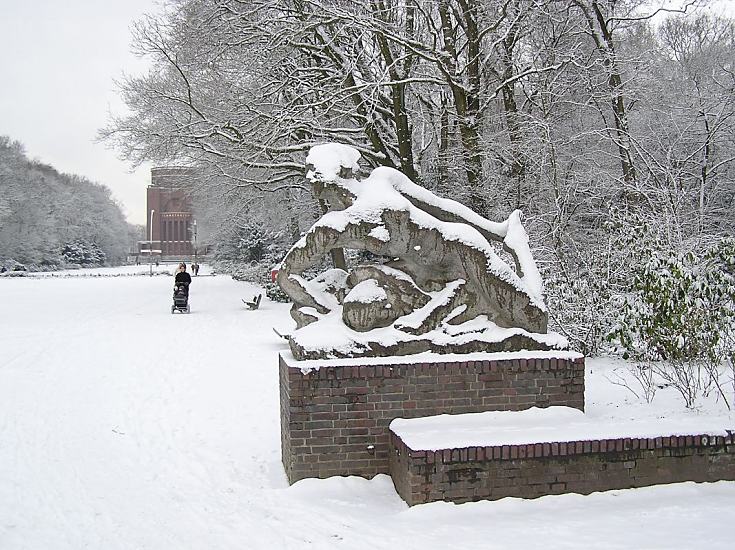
[610,240,735,407]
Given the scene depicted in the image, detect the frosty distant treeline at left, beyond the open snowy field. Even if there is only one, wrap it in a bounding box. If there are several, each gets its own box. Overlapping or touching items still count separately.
[0,136,138,269]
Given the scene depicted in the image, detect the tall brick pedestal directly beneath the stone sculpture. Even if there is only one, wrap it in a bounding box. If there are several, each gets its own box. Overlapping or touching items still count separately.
[280,355,584,483]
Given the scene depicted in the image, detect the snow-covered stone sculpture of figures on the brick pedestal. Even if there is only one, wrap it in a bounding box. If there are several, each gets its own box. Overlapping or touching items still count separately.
[277,144,566,359]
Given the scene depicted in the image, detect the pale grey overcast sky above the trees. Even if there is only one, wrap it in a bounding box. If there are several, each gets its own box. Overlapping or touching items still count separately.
[0,0,735,224]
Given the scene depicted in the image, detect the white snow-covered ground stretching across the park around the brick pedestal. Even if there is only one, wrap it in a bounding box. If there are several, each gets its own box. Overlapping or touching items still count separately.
[0,266,735,550]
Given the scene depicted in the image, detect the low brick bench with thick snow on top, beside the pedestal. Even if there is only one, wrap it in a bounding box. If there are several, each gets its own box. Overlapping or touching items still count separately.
[390,407,735,505]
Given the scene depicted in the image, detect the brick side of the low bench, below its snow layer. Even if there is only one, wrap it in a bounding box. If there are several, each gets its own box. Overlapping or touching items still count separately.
[390,433,735,505]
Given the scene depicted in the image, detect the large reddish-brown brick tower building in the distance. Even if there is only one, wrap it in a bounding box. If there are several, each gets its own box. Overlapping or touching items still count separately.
[139,167,196,260]
